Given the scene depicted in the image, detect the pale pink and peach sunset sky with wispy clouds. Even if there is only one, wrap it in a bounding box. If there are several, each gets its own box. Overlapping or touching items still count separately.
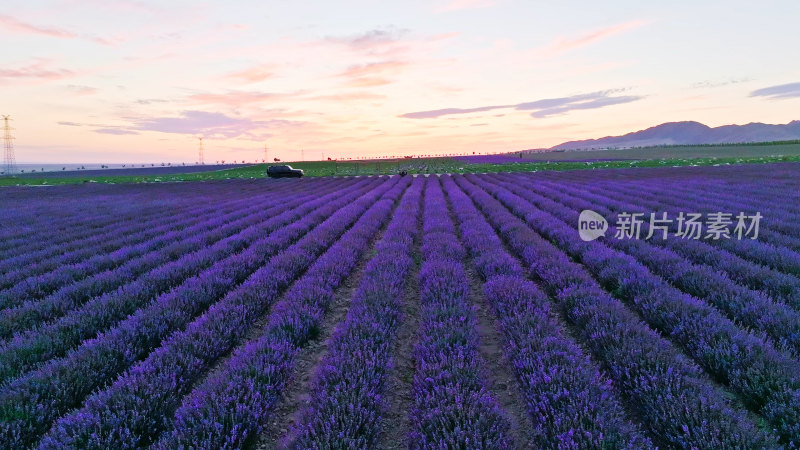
[0,0,800,163]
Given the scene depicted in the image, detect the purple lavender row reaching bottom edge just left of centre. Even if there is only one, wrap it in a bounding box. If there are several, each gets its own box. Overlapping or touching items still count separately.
[284,177,424,448]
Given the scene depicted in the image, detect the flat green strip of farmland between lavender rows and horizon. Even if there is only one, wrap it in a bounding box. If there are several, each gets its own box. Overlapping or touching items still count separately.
[0,143,800,186]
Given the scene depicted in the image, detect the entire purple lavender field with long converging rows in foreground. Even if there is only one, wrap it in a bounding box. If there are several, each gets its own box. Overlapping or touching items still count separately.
[0,162,800,449]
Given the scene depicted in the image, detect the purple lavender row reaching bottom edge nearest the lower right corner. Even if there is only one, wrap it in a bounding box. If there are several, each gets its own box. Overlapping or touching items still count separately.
[455,177,777,448]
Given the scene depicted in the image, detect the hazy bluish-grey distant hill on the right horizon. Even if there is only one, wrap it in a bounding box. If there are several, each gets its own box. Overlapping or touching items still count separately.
[552,120,800,150]
